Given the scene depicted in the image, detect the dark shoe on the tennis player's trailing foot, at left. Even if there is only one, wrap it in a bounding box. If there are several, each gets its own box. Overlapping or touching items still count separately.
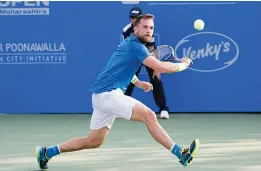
[36,147,49,170]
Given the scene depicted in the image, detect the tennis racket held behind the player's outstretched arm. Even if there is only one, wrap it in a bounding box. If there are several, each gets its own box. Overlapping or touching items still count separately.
[155,45,192,65]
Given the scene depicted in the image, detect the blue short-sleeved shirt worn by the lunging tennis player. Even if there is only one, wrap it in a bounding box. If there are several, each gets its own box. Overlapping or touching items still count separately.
[90,34,151,93]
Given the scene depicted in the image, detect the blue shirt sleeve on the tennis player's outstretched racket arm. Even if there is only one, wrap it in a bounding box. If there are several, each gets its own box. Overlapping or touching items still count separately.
[132,42,152,62]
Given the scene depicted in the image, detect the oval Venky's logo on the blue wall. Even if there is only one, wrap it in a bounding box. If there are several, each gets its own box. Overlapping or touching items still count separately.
[175,32,239,72]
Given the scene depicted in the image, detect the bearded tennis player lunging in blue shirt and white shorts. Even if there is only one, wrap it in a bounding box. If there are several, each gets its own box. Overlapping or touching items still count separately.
[36,14,199,169]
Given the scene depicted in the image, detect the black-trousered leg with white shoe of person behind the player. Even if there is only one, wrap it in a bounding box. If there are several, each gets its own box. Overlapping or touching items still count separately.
[146,66,169,119]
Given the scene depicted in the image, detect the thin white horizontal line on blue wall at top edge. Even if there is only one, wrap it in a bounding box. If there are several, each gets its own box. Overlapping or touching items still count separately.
[148,2,236,5]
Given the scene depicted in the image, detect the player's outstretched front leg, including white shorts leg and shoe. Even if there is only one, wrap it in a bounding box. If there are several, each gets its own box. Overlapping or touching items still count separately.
[111,90,199,166]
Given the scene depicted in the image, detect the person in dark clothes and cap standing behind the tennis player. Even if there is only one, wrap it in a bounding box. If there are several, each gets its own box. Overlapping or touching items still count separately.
[122,7,169,119]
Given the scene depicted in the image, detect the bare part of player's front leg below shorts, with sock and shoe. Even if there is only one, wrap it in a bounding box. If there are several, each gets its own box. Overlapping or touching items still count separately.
[131,102,199,166]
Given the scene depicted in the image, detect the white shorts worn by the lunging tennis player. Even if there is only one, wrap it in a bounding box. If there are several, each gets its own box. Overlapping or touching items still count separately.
[90,89,139,129]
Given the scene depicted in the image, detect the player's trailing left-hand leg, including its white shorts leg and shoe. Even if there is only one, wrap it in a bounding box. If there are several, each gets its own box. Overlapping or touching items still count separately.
[36,93,115,169]
